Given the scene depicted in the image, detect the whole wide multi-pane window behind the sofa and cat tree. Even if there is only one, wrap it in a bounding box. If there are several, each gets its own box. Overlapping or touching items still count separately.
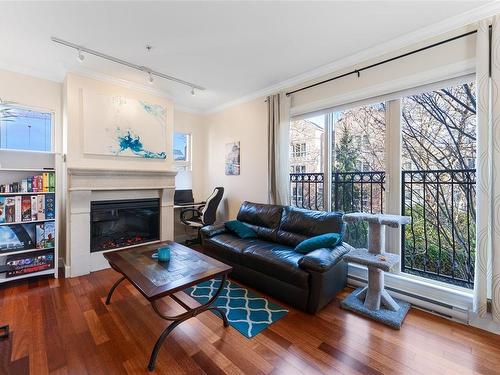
[290,76,477,288]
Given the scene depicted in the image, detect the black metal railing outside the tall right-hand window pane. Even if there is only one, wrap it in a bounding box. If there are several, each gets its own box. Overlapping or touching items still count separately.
[401,169,476,288]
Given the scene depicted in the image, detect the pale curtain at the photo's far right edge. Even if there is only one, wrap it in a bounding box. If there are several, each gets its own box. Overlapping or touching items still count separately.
[473,16,500,323]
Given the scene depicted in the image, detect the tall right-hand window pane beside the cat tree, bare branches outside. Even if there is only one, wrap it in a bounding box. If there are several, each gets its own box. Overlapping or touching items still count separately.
[401,82,476,288]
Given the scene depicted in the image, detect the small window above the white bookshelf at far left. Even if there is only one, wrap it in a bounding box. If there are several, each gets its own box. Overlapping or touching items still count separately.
[0,104,53,152]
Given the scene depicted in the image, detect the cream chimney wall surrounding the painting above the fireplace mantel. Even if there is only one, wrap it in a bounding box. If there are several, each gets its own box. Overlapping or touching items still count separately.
[64,73,174,170]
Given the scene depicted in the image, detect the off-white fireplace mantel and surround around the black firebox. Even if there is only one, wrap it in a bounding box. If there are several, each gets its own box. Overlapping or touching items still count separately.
[66,168,177,277]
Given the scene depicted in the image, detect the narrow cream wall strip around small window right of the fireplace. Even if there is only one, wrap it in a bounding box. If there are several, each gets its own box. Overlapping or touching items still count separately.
[174,110,207,201]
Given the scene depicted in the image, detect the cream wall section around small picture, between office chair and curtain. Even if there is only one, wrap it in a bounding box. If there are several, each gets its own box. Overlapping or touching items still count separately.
[204,98,268,220]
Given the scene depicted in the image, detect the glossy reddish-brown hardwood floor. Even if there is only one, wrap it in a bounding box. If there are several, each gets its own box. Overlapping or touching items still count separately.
[0,270,500,375]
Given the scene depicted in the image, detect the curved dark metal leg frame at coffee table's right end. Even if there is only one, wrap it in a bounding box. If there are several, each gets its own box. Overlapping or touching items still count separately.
[148,275,229,371]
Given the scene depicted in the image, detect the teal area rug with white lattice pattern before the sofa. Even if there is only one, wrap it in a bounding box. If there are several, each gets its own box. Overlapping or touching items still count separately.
[184,280,288,338]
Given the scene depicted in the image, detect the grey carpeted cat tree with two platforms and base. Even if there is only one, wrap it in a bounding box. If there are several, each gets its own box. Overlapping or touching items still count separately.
[341,212,411,329]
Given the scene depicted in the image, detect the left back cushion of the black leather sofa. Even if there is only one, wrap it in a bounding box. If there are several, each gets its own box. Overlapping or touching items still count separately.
[237,202,283,242]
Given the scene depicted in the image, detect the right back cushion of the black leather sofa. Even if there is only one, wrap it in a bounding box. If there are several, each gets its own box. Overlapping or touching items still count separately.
[277,206,345,247]
